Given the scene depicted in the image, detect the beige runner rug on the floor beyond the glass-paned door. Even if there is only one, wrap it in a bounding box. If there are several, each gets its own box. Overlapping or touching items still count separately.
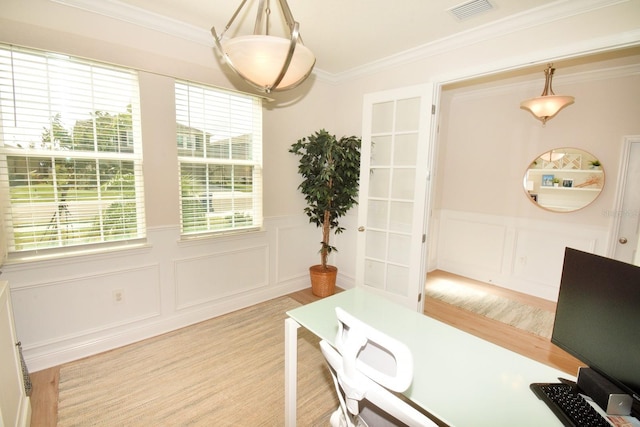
[426,281,555,338]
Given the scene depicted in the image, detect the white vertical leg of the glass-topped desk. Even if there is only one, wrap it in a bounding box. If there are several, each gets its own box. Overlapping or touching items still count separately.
[284,317,300,427]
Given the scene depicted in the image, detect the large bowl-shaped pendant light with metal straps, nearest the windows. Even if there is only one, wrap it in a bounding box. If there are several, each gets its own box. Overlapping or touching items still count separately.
[211,0,316,93]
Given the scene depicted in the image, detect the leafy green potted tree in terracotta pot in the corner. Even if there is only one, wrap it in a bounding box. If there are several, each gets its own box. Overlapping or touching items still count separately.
[289,129,361,297]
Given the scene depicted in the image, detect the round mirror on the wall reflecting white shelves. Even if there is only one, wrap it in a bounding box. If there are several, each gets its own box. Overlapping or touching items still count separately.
[523,148,604,212]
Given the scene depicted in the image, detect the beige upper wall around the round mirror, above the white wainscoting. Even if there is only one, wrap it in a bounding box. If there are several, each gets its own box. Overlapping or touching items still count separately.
[438,60,640,226]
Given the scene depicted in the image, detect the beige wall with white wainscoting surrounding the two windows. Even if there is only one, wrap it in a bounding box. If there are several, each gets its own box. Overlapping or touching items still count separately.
[0,0,353,371]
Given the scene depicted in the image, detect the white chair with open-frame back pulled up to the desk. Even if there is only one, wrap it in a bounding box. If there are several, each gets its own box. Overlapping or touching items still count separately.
[320,308,437,427]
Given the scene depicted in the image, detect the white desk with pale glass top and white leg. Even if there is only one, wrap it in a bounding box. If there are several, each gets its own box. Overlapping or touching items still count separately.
[285,289,566,427]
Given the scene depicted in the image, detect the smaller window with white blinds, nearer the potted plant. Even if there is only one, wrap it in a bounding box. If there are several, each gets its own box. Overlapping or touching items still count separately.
[175,82,262,235]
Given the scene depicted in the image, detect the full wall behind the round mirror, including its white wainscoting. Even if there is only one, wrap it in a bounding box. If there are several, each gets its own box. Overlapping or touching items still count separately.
[434,55,640,300]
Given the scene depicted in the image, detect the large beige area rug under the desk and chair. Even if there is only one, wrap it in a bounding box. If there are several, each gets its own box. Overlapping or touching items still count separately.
[58,297,338,426]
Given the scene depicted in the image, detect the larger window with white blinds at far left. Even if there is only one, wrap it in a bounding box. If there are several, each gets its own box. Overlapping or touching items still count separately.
[0,45,145,253]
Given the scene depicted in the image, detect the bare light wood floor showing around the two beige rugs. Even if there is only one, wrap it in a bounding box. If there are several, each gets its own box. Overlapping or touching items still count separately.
[31,271,582,427]
